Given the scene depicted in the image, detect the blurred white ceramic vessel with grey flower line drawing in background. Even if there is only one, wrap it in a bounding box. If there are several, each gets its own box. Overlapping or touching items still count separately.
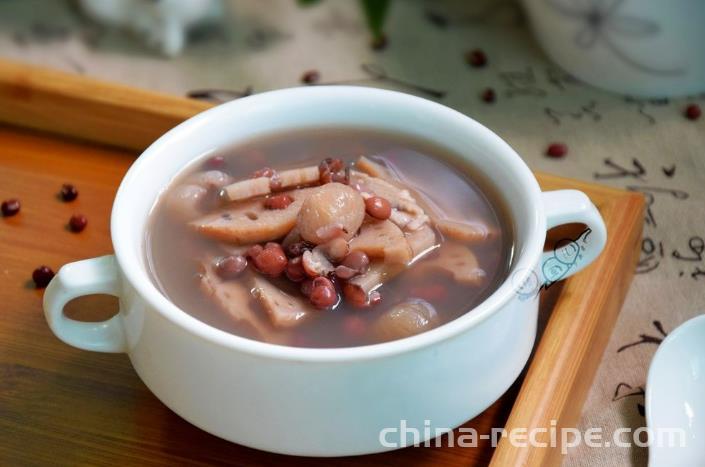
[522,0,705,98]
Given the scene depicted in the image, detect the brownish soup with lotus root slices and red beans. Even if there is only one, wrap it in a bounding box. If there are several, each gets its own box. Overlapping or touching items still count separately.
[145,129,513,347]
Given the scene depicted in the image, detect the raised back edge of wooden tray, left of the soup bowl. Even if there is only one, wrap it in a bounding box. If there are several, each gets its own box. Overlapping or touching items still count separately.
[0,60,212,150]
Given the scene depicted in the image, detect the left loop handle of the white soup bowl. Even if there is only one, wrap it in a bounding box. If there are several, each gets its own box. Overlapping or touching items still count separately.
[44,255,126,352]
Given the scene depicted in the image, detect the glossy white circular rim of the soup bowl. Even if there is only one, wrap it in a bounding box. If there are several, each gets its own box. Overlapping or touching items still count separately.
[110,85,546,362]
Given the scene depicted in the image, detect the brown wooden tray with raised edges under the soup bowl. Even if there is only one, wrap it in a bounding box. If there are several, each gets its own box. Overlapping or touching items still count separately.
[0,61,643,466]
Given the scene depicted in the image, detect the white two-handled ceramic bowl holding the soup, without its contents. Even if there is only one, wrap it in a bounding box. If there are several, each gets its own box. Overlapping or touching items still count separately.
[44,86,606,456]
